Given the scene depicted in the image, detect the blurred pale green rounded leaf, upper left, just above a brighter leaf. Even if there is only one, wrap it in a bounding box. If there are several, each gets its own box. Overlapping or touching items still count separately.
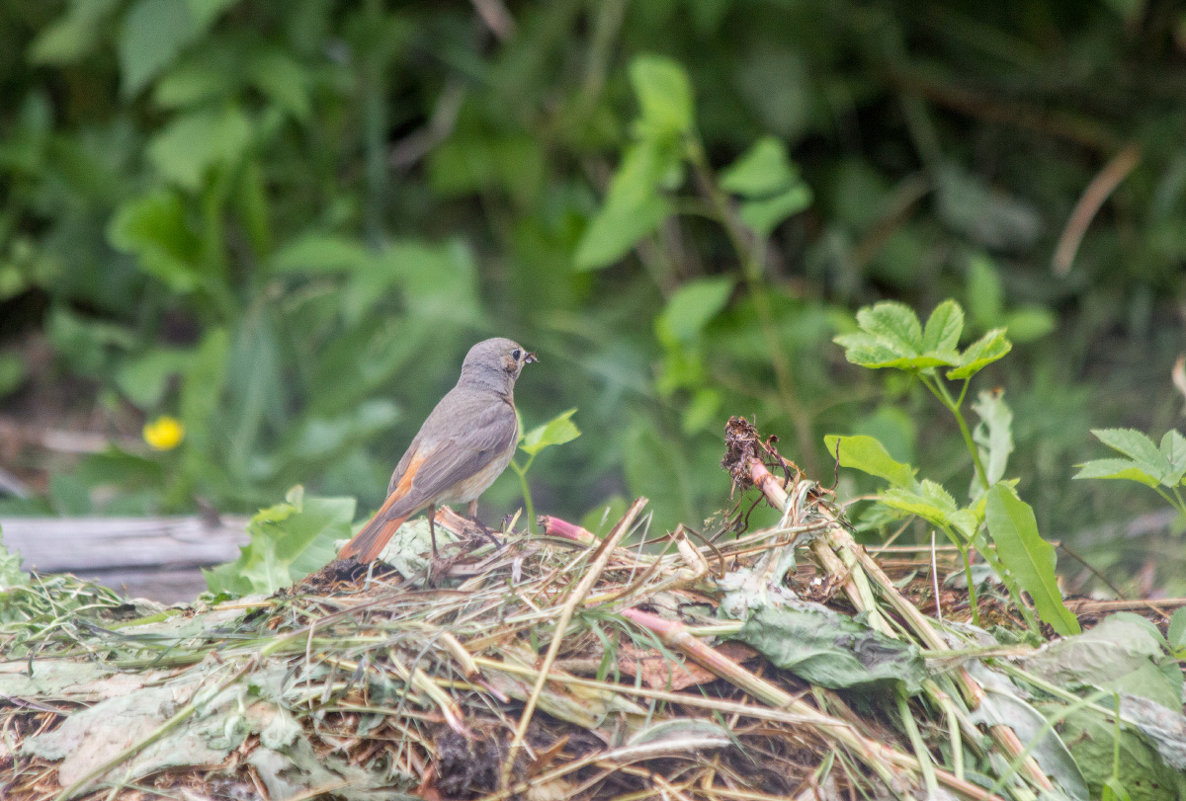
[148,106,251,191]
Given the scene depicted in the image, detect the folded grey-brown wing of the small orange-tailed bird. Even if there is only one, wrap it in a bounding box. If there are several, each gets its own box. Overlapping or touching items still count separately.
[387,398,518,516]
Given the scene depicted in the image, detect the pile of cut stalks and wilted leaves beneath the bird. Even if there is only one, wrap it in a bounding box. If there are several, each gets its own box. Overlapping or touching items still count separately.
[0,420,1186,801]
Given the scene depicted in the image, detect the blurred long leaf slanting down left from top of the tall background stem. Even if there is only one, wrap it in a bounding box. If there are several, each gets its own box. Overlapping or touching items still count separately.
[574,141,671,269]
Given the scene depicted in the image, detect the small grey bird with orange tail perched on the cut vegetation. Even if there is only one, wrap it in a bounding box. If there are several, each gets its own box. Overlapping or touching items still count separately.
[338,337,538,562]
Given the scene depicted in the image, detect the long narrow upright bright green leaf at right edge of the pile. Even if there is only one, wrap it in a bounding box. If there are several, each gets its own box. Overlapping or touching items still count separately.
[984,483,1079,636]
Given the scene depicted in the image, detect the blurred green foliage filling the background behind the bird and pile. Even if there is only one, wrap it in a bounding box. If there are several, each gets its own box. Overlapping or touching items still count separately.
[0,0,1186,588]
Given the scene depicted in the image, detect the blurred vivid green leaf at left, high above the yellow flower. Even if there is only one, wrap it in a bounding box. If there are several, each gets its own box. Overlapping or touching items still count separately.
[107,189,203,292]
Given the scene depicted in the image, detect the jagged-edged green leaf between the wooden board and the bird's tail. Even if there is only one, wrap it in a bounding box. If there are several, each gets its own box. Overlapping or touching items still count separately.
[202,487,355,596]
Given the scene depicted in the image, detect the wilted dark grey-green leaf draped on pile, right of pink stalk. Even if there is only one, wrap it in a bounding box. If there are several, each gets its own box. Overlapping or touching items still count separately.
[737,604,927,694]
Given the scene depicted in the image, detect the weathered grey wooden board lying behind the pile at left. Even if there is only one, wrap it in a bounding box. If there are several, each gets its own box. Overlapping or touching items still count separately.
[0,517,247,603]
